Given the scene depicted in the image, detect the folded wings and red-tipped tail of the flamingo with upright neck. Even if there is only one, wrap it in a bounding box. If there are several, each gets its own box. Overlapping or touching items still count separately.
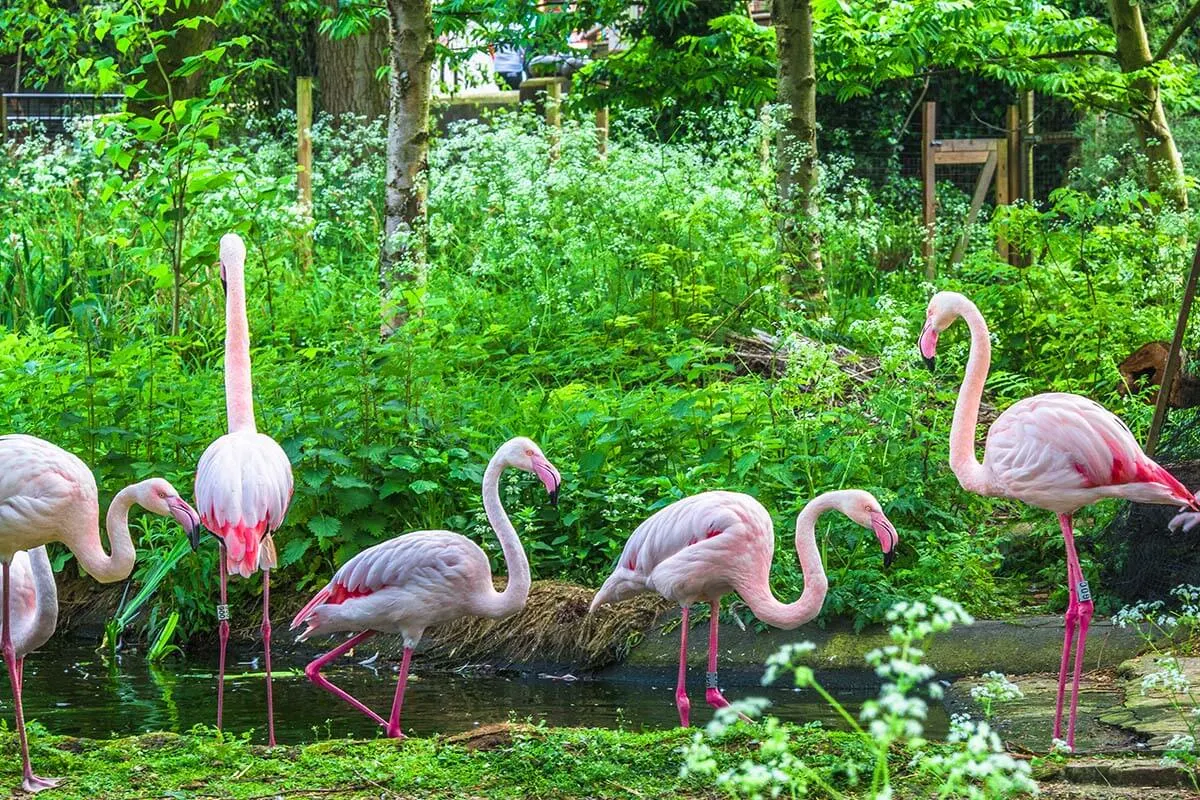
[196,432,293,578]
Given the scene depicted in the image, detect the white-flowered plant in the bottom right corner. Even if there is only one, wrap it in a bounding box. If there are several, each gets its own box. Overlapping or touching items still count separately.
[1112,584,1200,790]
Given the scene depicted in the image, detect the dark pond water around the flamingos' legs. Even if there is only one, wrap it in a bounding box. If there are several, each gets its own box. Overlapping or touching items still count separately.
[7,644,947,744]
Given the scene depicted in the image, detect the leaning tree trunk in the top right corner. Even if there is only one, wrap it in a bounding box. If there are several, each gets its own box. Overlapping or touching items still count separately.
[1109,0,1188,210]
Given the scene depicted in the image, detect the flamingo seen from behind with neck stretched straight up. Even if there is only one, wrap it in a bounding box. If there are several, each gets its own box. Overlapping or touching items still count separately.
[192,234,292,747]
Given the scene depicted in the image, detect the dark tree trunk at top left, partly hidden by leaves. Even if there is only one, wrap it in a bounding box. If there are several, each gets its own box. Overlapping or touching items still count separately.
[128,0,221,116]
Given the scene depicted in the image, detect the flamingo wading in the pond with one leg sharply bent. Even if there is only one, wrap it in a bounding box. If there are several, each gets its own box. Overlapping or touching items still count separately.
[292,437,563,739]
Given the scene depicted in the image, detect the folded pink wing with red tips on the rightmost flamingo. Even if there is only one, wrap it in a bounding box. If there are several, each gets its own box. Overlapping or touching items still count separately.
[984,392,1192,510]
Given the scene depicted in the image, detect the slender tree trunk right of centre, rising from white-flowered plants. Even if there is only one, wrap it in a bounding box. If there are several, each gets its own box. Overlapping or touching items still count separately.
[770,0,822,295]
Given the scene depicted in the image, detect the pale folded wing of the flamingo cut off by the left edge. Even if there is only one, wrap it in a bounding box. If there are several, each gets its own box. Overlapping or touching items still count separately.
[0,434,100,555]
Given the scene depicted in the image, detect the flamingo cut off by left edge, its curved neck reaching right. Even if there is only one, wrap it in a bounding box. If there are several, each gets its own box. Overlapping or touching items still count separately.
[0,434,199,792]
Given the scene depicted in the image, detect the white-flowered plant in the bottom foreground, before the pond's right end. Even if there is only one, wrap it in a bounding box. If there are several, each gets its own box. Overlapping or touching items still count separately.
[683,596,1037,800]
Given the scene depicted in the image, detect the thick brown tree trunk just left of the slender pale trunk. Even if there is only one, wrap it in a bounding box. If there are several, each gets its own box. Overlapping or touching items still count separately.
[317,0,388,120]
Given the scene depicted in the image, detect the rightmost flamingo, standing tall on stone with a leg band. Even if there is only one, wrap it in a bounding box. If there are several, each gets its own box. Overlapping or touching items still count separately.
[918,291,1200,748]
